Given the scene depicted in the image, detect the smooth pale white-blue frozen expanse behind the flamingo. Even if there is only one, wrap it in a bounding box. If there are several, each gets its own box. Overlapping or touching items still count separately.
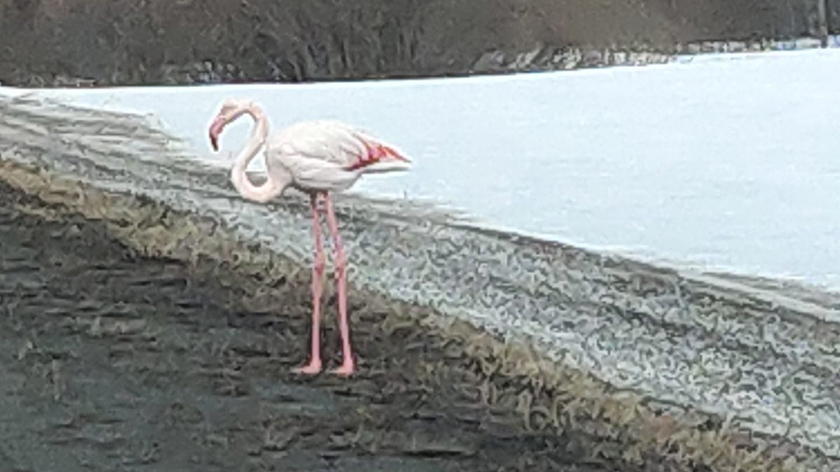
[6,49,840,288]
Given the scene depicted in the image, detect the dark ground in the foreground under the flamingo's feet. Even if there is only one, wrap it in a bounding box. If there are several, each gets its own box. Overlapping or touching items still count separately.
[0,182,648,472]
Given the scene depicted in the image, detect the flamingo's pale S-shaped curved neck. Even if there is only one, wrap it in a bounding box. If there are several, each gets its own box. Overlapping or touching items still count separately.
[230,104,285,202]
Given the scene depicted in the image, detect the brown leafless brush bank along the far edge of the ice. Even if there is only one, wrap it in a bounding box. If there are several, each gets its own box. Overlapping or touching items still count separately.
[0,0,828,86]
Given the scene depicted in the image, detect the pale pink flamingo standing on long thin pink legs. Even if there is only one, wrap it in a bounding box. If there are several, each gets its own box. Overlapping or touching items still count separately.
[210,99,411,376]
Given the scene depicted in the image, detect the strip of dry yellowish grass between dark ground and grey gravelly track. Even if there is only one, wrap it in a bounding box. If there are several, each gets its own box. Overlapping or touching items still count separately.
[0,156,827,472]
